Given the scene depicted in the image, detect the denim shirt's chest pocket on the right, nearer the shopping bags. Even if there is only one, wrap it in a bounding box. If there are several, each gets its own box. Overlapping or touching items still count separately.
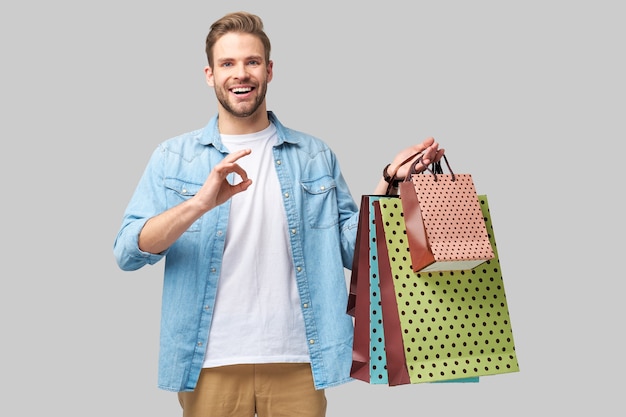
[302,176,339,229]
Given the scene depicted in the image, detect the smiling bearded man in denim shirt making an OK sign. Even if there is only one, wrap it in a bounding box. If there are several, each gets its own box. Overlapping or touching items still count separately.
[114,12,443,417]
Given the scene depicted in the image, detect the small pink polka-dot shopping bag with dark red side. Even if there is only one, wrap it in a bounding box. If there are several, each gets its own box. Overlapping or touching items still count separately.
[399,154,495,272]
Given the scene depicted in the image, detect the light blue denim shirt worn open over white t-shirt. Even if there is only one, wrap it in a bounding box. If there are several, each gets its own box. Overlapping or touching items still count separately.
[113,112,358,391]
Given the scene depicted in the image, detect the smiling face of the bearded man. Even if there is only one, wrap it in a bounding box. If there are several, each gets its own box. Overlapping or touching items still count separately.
[205,33,273,117]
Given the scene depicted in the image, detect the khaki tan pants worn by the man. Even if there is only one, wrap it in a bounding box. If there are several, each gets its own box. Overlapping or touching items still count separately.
[178,363,326,417]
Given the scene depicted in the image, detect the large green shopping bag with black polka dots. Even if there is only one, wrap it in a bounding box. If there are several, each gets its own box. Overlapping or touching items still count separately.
[378,195,519,384]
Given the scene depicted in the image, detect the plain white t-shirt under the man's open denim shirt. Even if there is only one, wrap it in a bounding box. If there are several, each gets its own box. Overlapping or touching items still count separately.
[204,124,310,367]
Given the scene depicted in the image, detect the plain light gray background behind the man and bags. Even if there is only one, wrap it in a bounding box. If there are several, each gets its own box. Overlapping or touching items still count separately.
[0,0,626,417]
